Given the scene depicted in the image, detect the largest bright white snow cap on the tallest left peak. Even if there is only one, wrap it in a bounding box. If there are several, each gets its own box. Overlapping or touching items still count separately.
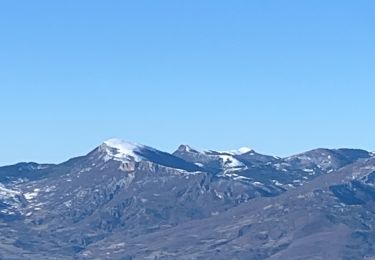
[103,138,147,162]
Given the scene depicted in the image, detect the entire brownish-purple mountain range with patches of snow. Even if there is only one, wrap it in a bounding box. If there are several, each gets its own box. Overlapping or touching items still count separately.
[0,139,375,260]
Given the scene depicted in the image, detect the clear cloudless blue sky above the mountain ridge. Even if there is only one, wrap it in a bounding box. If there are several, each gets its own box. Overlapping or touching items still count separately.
[0,0,375,165]
